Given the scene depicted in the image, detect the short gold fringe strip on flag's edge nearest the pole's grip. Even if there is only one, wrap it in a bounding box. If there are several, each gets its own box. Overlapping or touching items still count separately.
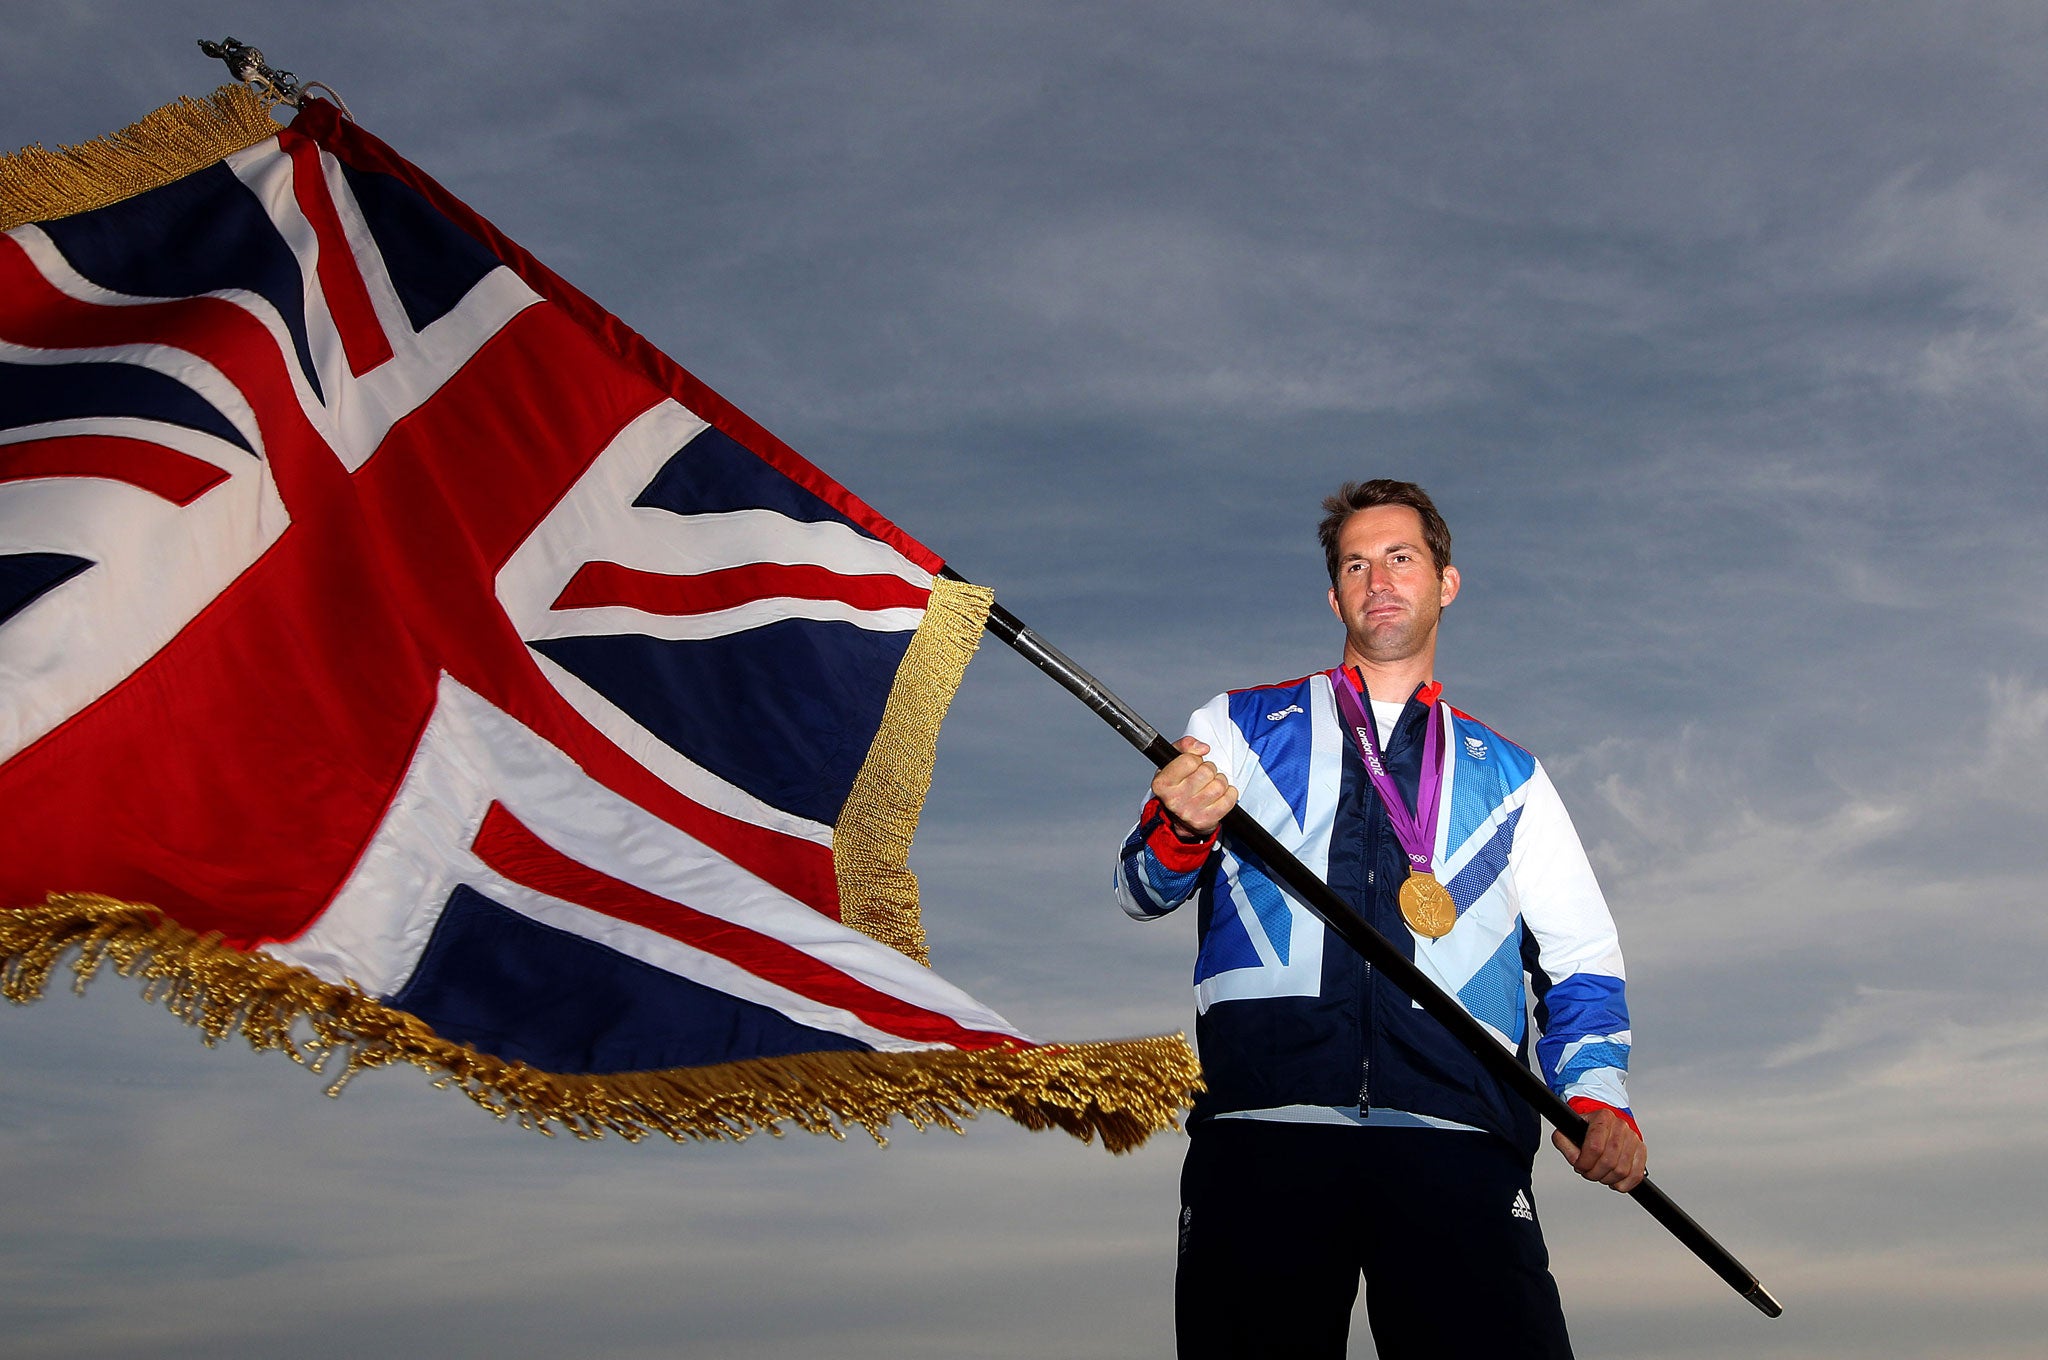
[831,578,995,963]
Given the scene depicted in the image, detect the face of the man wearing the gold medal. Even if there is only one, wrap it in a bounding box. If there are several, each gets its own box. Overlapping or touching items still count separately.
[1329,506,1458,662]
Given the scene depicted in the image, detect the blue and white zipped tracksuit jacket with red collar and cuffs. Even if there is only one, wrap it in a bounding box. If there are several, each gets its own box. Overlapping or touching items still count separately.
[1116,674,1630,1155]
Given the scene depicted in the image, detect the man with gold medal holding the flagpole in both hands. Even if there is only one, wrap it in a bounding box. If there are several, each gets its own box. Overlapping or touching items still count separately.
[1116,481,1645,1360]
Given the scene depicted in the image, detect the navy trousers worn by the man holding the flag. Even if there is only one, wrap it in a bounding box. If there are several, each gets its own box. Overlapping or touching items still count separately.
[1174,1118,1571,1360]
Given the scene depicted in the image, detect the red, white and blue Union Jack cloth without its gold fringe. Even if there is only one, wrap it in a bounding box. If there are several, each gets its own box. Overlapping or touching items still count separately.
[0,90,1186,1124]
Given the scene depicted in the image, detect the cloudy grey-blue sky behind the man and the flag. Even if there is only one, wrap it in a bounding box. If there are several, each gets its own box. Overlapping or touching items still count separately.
[0,0,2048,1360]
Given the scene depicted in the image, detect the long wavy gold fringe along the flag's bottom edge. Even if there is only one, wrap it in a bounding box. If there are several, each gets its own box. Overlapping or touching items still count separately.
[0,893,1200,1153]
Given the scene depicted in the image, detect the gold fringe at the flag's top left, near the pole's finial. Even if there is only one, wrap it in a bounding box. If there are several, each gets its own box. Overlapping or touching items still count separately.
[0,84,279,231]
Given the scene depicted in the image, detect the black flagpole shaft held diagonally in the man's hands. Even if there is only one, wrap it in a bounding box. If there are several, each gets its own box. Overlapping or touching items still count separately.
[940,567,1784,1317]
